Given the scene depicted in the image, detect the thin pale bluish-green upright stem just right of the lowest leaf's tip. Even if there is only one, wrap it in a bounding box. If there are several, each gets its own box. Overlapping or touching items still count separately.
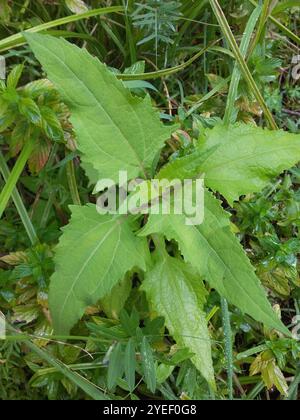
[221,297,233,400]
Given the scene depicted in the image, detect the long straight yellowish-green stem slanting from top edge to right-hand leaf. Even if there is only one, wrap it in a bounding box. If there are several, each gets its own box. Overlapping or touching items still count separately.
[209,0,278,130]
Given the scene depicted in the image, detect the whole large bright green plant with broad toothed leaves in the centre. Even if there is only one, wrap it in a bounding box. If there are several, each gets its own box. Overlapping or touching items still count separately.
[26,34,300,388]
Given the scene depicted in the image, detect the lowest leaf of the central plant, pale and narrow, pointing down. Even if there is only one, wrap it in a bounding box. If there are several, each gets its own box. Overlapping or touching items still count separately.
[142,253,214,387]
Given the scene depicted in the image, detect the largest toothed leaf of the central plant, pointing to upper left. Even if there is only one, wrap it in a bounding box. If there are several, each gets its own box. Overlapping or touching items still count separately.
[25,34,174,181]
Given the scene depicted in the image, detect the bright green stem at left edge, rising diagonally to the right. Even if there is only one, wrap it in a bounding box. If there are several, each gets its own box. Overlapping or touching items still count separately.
[0,140,34,219]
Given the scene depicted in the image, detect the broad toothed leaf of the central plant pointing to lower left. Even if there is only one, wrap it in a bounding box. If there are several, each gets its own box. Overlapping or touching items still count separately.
[49,204,146,334]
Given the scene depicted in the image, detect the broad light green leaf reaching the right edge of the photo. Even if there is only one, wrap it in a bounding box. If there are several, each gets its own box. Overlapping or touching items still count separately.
[160,124,300,204]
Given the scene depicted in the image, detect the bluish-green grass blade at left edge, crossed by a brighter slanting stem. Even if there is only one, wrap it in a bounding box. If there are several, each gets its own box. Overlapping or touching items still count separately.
[0,151,39,245]
